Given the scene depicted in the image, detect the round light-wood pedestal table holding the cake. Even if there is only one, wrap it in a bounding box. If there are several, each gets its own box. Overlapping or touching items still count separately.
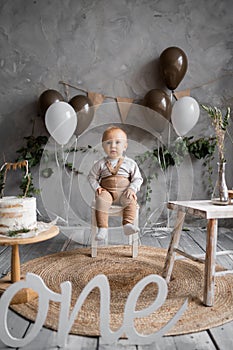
[0,226,59,304]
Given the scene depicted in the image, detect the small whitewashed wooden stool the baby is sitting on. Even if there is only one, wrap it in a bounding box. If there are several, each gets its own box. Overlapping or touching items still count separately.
[91,205,139,258]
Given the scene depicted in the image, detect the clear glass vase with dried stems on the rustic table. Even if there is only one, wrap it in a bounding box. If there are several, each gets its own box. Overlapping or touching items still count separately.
[201,104,231,205]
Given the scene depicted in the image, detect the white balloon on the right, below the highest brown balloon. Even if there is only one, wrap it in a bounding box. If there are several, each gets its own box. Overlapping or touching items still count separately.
[171,96,200,136]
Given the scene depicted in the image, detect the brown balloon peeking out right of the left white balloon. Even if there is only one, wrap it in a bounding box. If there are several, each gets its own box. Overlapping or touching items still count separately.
[69,95,94,135]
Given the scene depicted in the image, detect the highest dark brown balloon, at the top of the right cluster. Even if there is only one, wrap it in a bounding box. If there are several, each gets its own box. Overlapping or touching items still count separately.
[160,46,188,91]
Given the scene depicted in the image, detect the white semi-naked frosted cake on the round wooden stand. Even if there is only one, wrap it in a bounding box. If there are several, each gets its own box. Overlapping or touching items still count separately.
[0,196,37,235]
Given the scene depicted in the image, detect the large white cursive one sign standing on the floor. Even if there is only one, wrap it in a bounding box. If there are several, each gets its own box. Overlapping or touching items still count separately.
[0,273,187,348]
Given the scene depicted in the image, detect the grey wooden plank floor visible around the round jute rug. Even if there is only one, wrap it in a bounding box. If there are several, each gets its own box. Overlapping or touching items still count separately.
[0,227,233,350]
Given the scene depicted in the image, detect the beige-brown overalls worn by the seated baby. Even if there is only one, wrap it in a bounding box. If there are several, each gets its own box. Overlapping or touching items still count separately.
[96,158,137,228]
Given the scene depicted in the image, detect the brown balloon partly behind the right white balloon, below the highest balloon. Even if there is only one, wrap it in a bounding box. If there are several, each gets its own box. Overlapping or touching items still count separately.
[143,89,172,120]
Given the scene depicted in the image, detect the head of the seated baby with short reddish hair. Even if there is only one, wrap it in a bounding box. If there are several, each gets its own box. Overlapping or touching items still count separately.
[102,130,127,159]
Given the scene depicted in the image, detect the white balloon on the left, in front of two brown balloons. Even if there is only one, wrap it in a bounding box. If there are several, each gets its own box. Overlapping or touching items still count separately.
[45,101,77,145]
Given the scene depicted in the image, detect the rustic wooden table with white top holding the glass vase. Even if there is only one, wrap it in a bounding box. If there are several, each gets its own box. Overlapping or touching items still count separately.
[162,200,233,306]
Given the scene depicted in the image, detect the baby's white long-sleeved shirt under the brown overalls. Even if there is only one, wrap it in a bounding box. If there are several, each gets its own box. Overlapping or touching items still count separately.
[88,156,143,193]
